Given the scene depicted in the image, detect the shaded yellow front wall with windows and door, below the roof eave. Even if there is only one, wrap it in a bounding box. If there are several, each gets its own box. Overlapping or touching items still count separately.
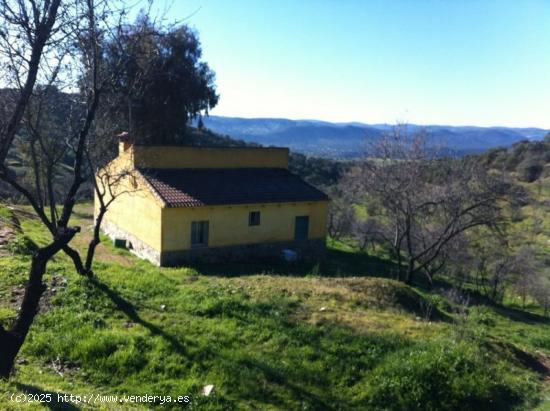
[162,201,328,251]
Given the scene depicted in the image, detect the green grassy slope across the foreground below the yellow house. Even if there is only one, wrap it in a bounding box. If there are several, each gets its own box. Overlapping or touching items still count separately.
[0,205,550,410]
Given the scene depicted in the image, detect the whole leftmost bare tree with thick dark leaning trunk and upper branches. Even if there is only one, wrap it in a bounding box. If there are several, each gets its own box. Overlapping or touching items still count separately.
[0,0,133,378]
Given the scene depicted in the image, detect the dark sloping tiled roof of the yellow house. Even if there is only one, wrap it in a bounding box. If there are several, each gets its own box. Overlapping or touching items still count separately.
[139,168,328,207]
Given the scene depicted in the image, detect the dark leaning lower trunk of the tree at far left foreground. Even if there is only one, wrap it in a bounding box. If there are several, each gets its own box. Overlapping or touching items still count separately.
[0,233,76,379]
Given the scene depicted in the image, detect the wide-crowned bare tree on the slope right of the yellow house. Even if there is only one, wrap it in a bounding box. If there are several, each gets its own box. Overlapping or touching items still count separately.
[348,126,520,282]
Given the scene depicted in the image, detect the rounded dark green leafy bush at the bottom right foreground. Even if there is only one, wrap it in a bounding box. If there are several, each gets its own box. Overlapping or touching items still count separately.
[360,340,536,410]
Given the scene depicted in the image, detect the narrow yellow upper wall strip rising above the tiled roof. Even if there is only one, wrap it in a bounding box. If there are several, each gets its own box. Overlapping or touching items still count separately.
[129,146,288,168]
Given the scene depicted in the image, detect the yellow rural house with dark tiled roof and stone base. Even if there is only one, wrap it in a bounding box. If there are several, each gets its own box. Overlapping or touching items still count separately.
[96,139,328,266]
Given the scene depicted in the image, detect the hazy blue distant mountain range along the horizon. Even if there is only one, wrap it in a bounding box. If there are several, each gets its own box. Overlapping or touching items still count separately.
[204,116,548,158]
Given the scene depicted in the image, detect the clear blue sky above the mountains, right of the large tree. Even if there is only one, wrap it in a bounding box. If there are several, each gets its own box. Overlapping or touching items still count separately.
[157,0,550,128]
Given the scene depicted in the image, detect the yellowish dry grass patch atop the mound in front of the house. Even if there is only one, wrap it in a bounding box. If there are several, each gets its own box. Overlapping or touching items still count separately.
[226,275,448,338]
